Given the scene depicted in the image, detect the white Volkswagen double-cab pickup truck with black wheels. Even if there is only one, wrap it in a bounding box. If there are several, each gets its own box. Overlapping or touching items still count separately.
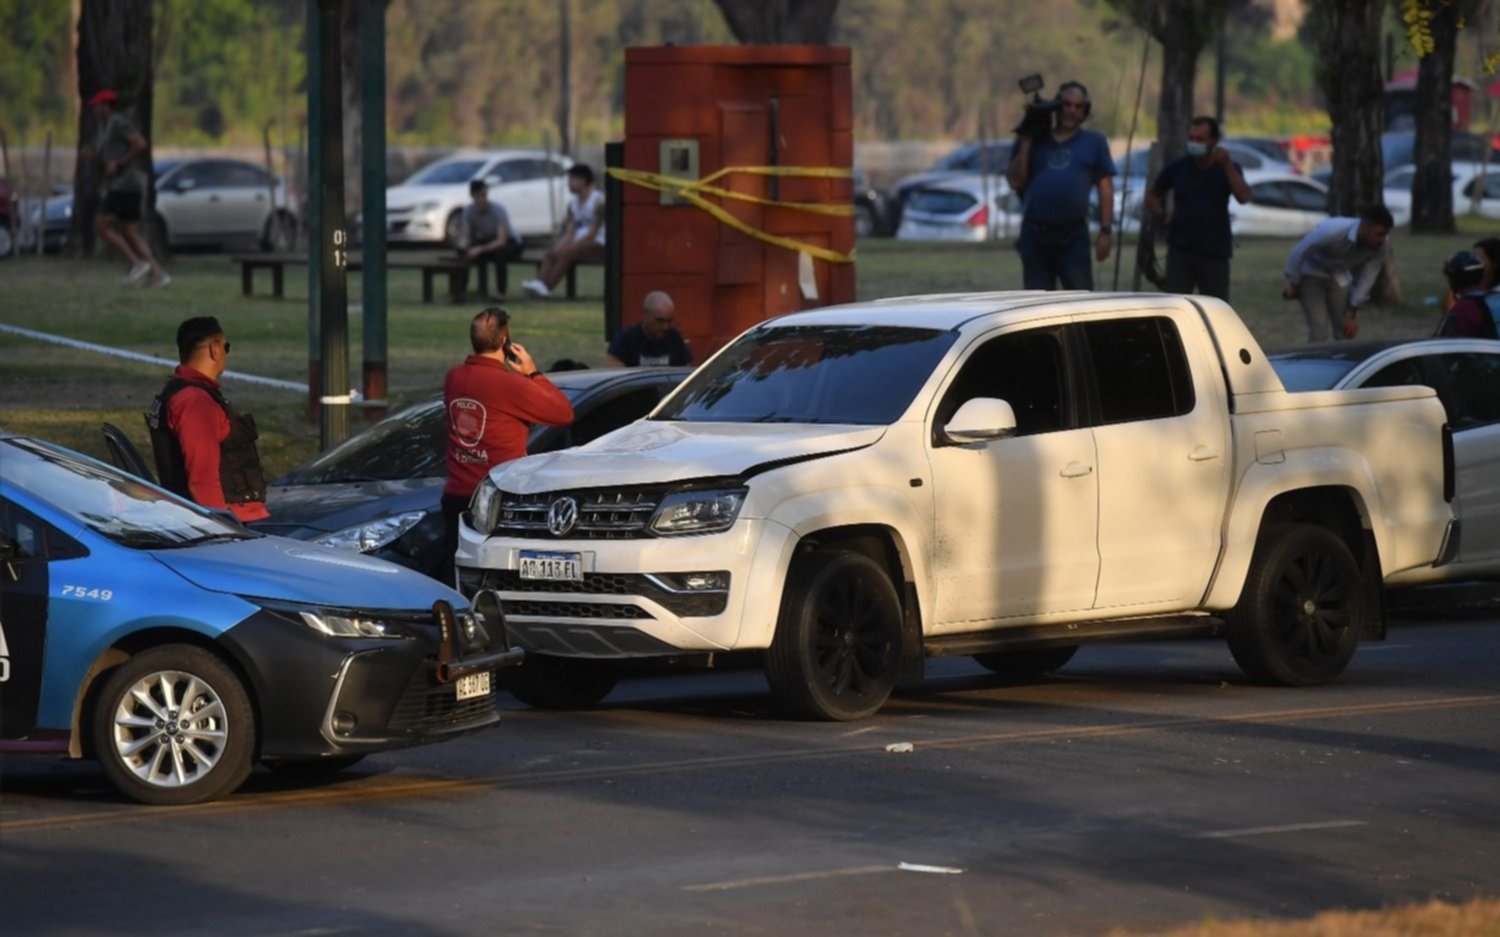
[458,292,1457,720]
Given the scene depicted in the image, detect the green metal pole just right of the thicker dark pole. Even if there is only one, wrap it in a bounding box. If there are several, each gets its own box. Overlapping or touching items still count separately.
[360,0,387,418]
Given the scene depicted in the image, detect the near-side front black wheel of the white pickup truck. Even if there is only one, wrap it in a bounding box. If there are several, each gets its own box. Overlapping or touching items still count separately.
[765,550,902,721]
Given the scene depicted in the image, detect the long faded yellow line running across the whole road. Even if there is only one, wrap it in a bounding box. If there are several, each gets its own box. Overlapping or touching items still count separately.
[0,694,1500,834]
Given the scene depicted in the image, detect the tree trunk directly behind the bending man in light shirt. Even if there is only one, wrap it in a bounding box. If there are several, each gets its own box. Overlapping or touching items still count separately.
[1308,0,1386,216]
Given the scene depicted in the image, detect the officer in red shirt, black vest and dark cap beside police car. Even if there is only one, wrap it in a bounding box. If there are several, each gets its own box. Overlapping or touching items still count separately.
[146,316,270,520]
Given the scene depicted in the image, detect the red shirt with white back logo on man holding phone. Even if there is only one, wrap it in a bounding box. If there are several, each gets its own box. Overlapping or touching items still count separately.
[443,355,573,498]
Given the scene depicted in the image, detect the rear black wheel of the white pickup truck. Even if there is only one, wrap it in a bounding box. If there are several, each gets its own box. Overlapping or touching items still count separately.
[1229,523,1365,687]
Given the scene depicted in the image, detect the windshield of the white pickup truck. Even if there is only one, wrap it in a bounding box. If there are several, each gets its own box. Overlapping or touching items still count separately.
[653,325,957,426]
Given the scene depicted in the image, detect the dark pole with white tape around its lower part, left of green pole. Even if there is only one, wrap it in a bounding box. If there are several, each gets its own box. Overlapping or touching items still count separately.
[312,0,350,450]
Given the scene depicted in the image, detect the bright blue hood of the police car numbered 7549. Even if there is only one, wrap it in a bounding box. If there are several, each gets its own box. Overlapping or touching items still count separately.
[152,537,468,610]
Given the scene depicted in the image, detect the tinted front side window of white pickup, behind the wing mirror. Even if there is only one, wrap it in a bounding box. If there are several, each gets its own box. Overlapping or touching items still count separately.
[936,328,1073,436]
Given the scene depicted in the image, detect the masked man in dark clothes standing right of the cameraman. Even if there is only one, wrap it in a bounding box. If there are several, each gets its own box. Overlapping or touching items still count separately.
[1146,117,1250,300]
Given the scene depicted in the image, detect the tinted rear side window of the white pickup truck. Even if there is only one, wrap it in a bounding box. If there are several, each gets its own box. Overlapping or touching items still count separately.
[1083,316,1193,424]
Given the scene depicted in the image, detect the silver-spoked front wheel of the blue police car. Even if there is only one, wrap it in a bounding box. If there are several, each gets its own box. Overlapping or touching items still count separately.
[92,645,255,805]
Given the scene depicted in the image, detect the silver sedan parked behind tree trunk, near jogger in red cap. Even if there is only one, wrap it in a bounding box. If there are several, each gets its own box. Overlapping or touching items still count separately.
[33,157,299,252]
